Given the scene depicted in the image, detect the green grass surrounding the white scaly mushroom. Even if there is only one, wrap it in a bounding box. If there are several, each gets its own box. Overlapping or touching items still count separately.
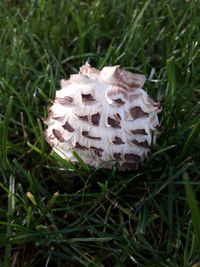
[0,0,200,267]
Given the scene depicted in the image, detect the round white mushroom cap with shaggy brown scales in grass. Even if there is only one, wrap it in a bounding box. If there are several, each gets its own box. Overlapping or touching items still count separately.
[45,64,162,170]
